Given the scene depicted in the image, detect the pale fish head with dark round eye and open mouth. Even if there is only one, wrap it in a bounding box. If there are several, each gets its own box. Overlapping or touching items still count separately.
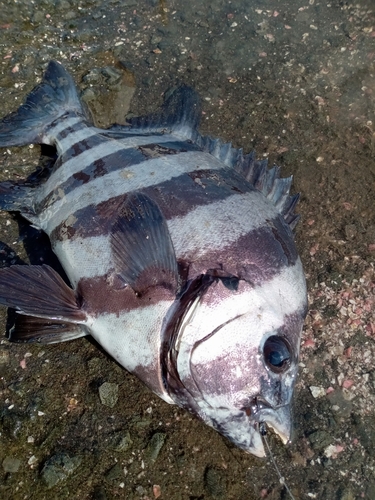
[166,269,306,457]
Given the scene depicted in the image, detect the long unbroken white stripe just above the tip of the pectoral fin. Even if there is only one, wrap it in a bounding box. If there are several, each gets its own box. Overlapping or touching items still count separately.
[40,151,225,233]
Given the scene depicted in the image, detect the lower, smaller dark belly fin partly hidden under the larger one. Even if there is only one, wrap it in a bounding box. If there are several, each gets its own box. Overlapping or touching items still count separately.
[8,314,87,344]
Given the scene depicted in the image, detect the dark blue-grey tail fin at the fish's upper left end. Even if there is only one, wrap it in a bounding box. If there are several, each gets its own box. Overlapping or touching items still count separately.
[0,61,84,147]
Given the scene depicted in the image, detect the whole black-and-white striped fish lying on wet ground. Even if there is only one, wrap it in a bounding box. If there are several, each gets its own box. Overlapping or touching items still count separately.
[0,61,307,457]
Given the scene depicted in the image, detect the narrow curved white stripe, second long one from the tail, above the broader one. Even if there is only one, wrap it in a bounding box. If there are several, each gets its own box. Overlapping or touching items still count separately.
[38,133,195,202]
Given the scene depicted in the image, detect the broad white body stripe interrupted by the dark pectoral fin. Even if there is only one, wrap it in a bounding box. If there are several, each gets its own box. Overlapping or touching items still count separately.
[53,189,277,284]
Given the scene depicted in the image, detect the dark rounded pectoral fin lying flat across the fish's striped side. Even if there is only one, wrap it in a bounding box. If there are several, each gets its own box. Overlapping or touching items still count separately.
[111,193,177,293]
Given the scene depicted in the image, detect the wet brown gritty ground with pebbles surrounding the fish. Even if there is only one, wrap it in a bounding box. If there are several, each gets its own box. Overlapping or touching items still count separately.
[0,0,375,500]
